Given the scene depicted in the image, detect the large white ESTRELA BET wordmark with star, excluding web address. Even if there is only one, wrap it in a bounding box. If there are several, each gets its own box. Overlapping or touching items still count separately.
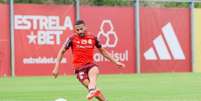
[15,15,73,46]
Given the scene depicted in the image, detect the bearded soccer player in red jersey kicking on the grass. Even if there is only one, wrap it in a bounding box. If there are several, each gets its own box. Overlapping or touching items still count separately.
[52,20,125,101]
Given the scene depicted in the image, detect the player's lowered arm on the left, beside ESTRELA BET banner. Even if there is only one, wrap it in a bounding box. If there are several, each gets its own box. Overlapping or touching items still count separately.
[52,39,72,78]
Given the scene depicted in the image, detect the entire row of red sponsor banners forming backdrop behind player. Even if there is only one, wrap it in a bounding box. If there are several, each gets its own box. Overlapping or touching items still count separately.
[0,4,191,76]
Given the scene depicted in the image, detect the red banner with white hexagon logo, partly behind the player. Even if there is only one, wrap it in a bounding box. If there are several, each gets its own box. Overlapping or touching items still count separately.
[81,6,136,74]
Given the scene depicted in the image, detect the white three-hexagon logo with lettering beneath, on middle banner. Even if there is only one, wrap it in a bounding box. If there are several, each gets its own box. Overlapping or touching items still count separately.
[94,20,128,62]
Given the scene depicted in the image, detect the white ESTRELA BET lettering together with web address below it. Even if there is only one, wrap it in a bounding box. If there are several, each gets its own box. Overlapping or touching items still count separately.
[14,15,73,64]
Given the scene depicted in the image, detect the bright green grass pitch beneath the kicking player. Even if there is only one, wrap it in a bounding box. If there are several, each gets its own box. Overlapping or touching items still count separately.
[0,73,201,101]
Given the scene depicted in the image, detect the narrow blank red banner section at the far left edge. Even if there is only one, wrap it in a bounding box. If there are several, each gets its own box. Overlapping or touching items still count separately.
[0,4,10,76]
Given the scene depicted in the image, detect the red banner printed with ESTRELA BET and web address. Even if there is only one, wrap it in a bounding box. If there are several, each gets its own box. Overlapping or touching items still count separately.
[14,4,74,76]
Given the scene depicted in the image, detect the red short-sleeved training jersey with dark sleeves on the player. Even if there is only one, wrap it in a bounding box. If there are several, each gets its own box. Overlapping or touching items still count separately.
[64,32,102,69]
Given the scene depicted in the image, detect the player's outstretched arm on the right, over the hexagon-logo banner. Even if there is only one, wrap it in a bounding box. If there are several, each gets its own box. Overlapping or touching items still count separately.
[95,38,125,68]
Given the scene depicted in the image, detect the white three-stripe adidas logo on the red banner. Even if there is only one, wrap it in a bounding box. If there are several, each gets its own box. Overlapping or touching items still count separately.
[144,23,185,60]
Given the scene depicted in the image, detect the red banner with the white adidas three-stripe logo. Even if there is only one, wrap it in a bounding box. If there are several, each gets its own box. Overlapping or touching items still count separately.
[140,8,191,73]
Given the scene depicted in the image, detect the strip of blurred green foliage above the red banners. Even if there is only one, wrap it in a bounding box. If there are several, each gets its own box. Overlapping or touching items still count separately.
[0,0,201,8]
